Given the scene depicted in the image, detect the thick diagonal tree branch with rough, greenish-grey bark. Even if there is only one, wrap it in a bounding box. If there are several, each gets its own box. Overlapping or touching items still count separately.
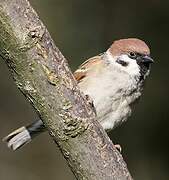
[0,0,132,180]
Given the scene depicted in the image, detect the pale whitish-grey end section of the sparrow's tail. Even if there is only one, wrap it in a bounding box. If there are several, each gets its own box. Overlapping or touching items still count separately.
[3,127,31,151]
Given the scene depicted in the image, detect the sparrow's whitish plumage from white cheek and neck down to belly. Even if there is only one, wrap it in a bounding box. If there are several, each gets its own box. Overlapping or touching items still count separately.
[79,53,141,130]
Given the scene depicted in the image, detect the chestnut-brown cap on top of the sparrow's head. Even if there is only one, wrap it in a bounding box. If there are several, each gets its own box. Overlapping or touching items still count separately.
[109,38,150,56]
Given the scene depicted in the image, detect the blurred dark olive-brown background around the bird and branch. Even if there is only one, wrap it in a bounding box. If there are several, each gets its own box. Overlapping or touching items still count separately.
[0,0,169,180]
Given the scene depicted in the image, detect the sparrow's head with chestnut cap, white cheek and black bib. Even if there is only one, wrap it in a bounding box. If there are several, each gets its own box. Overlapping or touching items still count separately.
[107,38,154,79]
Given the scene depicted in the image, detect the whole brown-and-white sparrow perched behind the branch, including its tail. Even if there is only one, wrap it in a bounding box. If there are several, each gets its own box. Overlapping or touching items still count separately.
[3,38,154,150]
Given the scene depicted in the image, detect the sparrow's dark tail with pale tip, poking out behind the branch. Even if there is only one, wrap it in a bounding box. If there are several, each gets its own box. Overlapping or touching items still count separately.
[3,120,45,151]
